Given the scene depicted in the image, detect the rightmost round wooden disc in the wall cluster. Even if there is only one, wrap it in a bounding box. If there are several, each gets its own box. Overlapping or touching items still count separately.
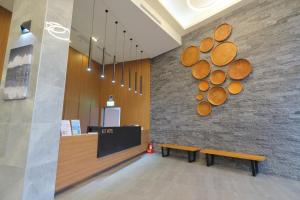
[228,59,252,80]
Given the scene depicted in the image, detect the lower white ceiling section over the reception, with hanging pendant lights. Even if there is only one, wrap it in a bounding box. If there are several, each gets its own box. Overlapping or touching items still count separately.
[70,0,181,62]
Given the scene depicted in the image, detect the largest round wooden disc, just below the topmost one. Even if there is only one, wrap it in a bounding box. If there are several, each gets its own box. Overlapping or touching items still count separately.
[210,42,237,67]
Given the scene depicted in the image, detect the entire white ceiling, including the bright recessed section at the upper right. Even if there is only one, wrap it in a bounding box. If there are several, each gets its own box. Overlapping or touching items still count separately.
[0,0,246,63]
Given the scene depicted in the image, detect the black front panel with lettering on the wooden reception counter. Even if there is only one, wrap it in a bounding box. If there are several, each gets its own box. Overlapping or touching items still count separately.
[89,126,141,158]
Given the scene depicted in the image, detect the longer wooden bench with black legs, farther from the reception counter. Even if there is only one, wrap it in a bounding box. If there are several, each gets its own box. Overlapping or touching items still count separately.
[201,149,267,176]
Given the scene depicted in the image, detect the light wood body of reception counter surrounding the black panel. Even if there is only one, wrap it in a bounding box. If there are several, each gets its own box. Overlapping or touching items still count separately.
[55,131,150,192]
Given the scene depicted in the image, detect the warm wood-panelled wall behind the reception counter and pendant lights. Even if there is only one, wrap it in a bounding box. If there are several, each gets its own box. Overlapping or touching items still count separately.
[63,48,150,132]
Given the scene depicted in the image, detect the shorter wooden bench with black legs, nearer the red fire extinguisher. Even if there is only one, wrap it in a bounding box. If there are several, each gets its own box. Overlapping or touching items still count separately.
[159,144,201,162]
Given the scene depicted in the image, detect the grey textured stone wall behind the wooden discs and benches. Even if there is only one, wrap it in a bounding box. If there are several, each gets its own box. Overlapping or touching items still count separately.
[151,0,300,179]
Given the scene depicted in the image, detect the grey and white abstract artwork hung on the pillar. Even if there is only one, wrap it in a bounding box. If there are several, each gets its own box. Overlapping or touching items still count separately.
[4,45,33,100]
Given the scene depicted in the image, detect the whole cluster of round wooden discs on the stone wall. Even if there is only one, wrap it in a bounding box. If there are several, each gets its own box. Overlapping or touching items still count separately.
[181,23,252,116]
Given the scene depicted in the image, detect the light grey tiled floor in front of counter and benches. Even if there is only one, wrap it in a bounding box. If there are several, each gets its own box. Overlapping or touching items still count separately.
[55,154,300,200]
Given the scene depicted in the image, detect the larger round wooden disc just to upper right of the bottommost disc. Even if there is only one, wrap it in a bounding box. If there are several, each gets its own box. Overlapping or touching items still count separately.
[207,86,227,106]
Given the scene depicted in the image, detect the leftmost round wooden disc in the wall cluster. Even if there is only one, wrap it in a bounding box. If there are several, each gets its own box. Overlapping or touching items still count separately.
[180,46,200,67]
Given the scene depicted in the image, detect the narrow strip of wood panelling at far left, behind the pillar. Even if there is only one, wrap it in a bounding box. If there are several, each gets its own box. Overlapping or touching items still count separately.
[0,6,11,81]
